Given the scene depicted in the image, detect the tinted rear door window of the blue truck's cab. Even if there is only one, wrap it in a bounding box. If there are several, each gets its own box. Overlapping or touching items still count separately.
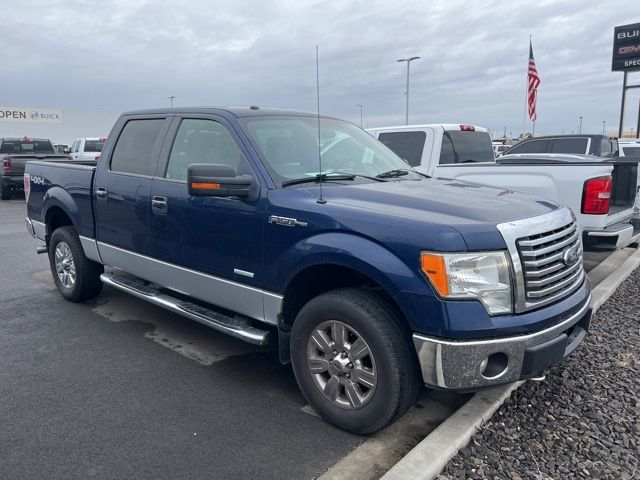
[111,118,164,176]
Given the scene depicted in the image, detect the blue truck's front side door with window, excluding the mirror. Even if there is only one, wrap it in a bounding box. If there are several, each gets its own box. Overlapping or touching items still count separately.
[149,115,267,310]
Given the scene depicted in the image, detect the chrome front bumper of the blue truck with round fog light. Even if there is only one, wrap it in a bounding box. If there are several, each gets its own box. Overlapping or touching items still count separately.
[413,295,591,390]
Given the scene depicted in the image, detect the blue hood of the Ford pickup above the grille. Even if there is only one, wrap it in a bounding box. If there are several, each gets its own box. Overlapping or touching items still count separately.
[324,179,559,250]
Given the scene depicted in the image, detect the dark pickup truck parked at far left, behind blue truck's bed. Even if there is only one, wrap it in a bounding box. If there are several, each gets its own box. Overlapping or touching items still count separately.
[0,137,69,200]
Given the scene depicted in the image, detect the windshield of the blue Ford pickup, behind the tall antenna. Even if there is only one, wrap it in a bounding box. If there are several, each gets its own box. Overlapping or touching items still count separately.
[241,116,420,184]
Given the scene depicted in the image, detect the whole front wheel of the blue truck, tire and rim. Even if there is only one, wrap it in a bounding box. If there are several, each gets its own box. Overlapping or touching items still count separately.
[291,289,422,434]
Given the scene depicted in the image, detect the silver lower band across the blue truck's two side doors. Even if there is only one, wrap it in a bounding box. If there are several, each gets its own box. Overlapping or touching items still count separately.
[97,241,283,325]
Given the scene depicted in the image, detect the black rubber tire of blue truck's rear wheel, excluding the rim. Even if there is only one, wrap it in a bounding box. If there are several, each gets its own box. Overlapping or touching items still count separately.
[49,227,104,302]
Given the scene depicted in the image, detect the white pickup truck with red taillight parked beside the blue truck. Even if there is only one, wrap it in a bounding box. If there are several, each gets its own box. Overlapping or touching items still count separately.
[368,124,640,251]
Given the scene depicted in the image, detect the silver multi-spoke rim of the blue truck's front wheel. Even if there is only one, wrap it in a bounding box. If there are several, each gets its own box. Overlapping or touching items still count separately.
[307,320,378,410]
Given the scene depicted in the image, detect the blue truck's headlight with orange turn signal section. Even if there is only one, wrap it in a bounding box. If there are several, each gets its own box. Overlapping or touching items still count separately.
[420,252,512,315]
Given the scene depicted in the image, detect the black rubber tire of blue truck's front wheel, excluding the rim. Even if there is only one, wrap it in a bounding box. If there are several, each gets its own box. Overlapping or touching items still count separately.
[290,289,423,434]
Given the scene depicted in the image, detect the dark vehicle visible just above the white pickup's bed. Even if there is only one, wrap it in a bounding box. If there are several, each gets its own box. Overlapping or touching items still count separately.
[503,134,618,157]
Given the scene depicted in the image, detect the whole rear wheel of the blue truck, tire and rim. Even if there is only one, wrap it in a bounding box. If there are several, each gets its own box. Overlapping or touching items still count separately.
[49,227,104,302]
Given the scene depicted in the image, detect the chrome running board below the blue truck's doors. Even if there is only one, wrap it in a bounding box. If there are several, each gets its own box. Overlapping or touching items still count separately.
[100,272,269,345]
